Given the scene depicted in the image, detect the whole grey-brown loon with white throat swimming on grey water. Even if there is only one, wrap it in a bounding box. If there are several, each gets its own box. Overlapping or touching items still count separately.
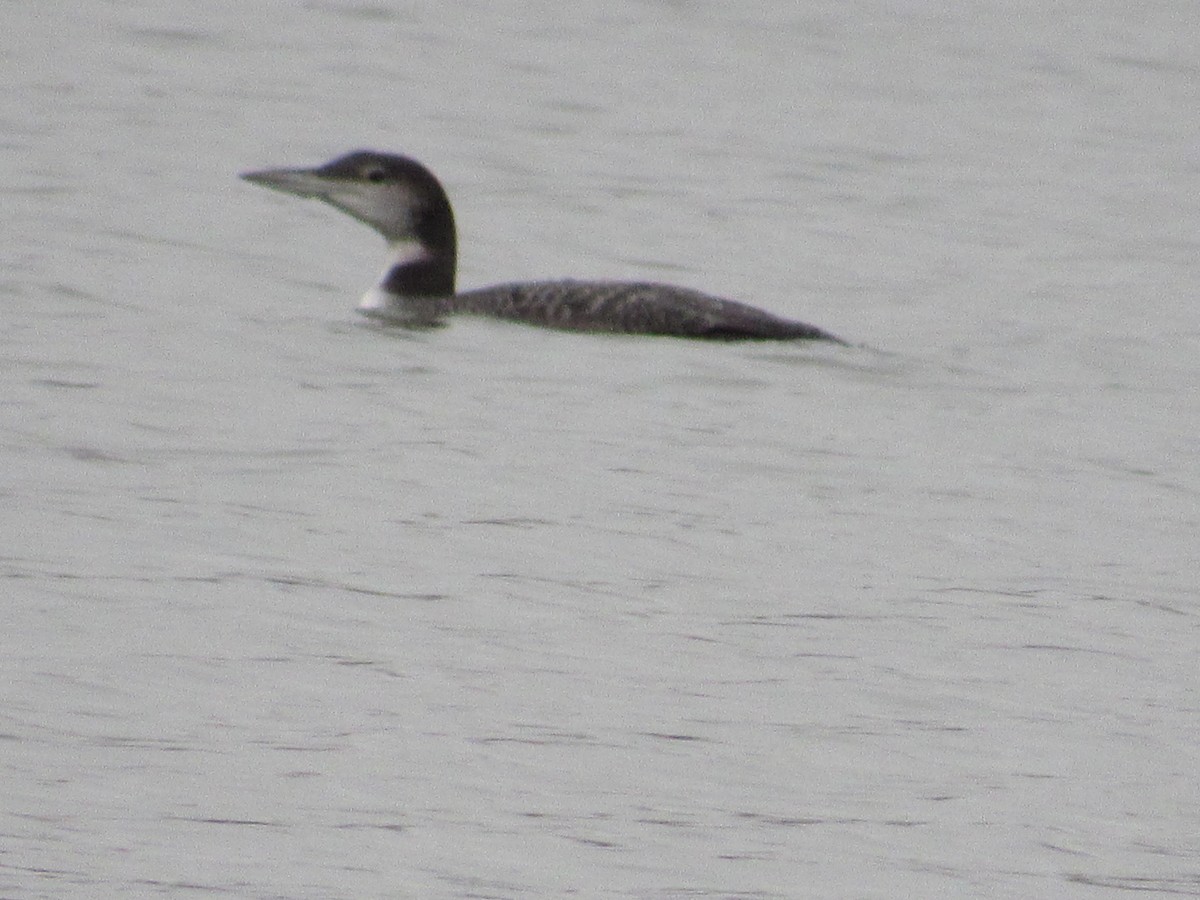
[241,150,845,343]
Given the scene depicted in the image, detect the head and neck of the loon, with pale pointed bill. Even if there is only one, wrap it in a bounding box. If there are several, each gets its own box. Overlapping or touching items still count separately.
[241,150,457,301]
